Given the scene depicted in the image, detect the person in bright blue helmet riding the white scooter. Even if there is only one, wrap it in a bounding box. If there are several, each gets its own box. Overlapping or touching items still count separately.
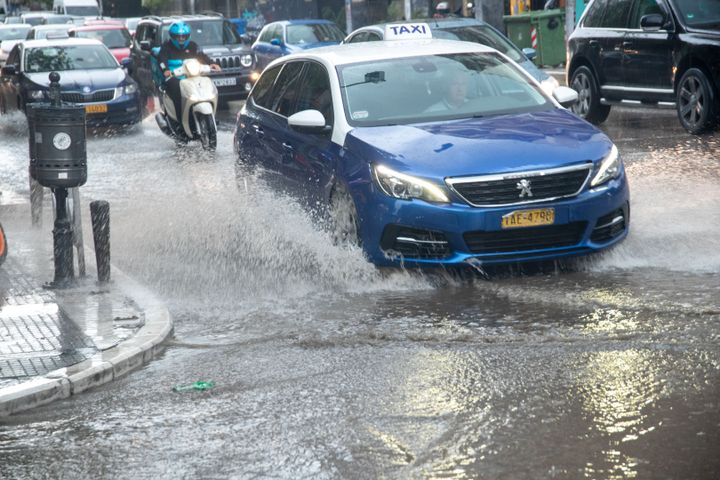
[158,21,221,121]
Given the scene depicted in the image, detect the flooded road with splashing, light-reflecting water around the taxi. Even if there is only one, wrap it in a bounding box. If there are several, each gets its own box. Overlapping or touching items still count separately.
[0,109,720,479]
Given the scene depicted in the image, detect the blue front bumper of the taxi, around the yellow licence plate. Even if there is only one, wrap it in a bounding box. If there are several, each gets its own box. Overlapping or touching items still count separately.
[355,172,630,267]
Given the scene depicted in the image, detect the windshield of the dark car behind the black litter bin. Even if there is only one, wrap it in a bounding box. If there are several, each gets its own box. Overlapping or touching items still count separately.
[25,45,118,73]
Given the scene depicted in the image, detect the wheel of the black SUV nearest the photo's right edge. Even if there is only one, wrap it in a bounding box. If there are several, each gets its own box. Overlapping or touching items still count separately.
[676,68,718,135]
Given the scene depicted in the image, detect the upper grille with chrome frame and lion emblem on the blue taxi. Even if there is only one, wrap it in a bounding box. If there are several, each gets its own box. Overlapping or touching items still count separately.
[447,163,592,207]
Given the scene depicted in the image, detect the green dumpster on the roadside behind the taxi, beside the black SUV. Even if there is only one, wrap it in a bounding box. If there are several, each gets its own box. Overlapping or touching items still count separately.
[503,9,565,66]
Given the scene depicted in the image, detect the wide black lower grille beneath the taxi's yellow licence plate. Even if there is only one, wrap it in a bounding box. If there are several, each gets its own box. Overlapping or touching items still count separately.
[463,222,587,253]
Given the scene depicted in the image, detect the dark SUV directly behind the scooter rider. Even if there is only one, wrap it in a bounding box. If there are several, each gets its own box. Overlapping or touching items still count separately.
[130,14,257,110]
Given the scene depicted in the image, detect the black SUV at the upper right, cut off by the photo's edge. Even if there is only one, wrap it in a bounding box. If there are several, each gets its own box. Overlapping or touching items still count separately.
[567,0,720,134]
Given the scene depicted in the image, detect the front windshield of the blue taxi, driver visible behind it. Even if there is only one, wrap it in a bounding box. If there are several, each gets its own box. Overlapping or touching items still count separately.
[338,53,554,126]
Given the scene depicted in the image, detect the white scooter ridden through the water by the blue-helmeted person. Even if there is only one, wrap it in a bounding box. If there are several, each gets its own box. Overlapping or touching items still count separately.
[155,58,218,151]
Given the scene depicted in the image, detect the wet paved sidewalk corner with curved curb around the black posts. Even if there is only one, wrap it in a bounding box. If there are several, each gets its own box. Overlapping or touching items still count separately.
[0,192,172,418]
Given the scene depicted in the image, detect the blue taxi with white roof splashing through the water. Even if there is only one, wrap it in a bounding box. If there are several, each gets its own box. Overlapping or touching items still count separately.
[234,24,630,266]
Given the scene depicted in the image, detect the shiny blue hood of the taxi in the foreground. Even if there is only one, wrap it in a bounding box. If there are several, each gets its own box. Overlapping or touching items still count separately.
[345,108,612,179]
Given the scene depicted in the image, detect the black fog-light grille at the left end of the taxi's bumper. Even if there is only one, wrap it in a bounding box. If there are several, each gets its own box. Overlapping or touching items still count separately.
[380,225,451,259]
